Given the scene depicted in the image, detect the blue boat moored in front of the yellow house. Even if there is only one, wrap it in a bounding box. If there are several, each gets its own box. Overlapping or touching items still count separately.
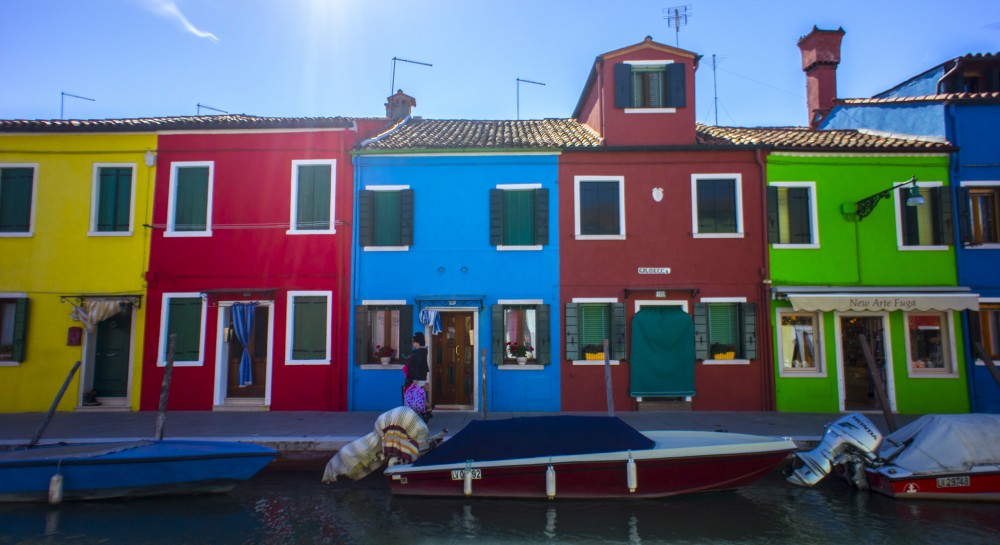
[0,440,277,503]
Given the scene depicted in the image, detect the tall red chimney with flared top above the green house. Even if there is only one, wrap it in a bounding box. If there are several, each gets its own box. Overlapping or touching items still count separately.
[798,26,844,128]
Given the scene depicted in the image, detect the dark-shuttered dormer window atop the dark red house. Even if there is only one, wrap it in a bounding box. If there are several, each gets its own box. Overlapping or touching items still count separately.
[615,60,687,113]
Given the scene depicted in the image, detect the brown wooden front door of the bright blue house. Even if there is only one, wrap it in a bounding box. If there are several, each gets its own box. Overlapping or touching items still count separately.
[431,312,476,405]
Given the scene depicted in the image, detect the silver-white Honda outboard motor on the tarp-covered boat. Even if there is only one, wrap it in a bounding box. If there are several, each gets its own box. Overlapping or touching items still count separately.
[788,413,882,486]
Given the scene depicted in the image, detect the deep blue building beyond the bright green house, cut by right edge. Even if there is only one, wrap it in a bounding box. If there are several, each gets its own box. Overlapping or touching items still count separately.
[819,54,1000,413]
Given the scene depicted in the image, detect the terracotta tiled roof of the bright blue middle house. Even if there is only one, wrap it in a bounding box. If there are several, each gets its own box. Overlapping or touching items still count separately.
[360,117,601,151]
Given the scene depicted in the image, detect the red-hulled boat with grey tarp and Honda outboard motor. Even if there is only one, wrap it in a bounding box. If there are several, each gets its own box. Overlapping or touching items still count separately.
[788,414,1000,501]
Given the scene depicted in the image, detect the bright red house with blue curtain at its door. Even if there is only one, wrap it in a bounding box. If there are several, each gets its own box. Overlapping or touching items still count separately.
[141,115,386,410]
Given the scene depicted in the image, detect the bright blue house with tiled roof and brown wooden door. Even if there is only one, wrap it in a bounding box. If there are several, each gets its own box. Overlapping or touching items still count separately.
[349,105,597,412]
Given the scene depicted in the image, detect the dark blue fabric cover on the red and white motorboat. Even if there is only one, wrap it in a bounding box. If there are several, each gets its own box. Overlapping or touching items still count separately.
[413,415,655,466]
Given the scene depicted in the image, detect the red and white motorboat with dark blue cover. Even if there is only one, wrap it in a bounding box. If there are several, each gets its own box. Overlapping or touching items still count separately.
[385,416,796,499]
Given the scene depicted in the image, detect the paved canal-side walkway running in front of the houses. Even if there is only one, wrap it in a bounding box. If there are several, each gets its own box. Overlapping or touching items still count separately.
[0,410,917,459]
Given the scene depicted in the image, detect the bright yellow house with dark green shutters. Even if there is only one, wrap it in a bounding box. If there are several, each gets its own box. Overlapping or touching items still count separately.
[0,125,156,412]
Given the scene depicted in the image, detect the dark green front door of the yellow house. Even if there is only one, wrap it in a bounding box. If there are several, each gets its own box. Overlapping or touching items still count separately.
[94,305,132,397]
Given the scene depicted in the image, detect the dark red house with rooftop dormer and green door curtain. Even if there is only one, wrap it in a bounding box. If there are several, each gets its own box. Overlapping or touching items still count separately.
[559,37,773,411]
